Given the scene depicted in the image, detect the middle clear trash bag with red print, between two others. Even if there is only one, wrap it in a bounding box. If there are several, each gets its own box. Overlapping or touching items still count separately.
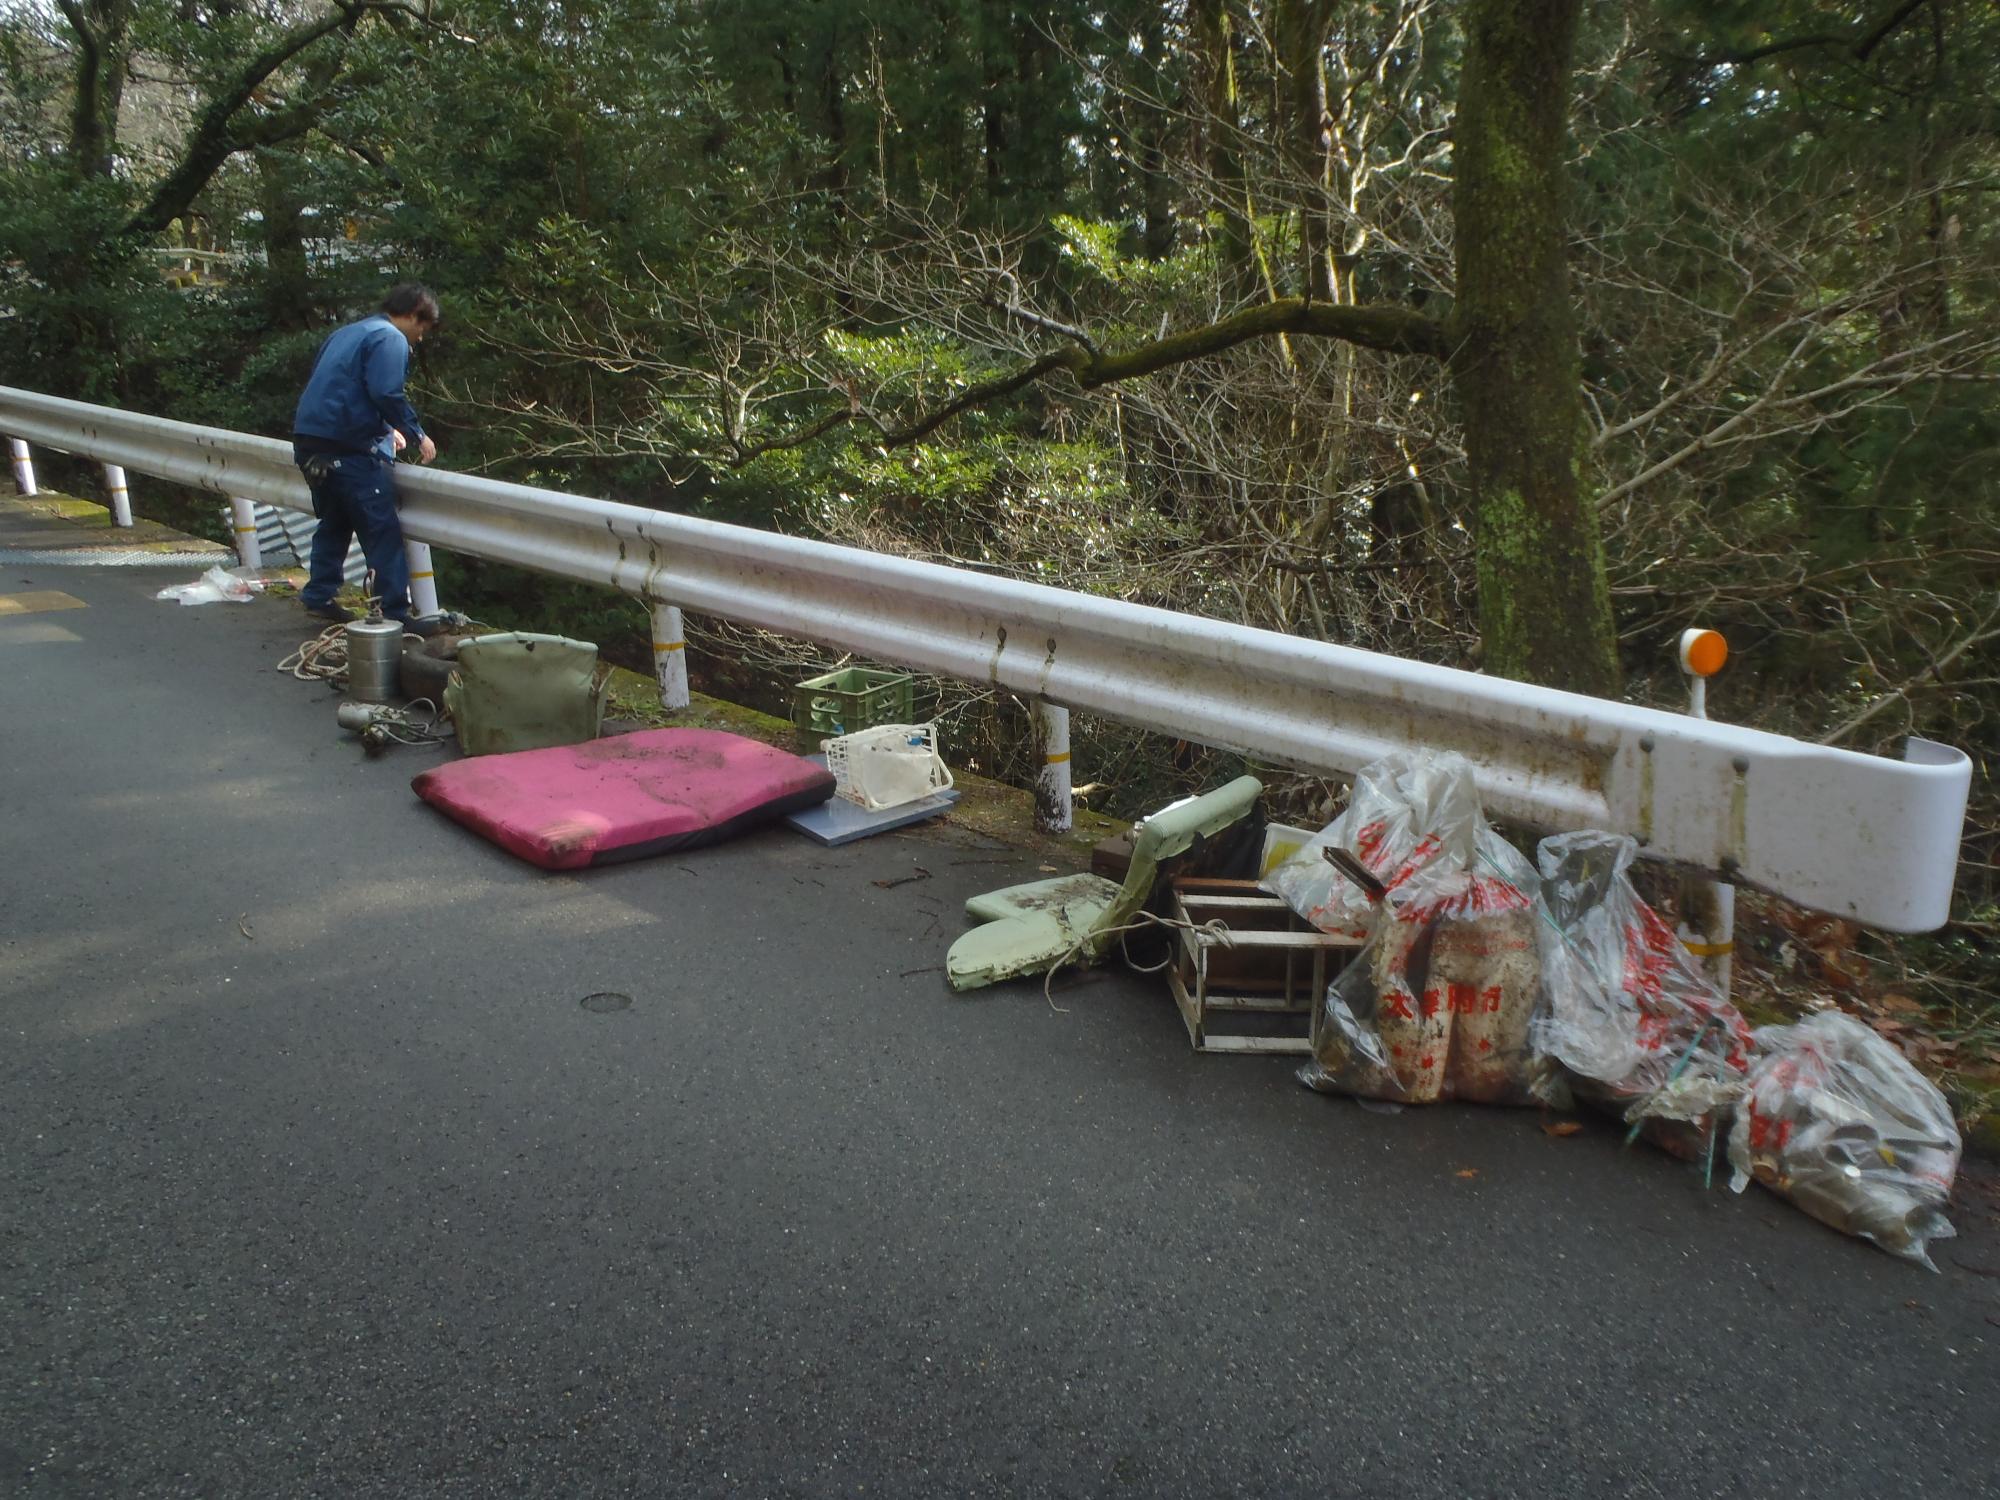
[1534,832,1754,1160]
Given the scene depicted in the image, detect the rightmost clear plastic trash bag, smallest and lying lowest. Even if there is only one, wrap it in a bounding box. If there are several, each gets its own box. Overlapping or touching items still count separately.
[1730,1010,1962,1270]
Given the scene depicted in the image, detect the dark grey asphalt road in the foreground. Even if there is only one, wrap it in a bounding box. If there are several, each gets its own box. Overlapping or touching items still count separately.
[0,566,2000,1500]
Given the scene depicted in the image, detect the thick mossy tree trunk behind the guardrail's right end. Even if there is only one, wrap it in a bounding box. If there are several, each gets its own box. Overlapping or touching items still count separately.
[1452,0,1618,696]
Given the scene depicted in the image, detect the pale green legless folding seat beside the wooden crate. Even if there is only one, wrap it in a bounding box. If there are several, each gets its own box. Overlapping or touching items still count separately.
[944,776,1264,990]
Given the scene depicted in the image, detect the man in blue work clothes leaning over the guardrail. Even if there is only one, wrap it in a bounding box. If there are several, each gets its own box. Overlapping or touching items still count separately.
[292,282,444,636]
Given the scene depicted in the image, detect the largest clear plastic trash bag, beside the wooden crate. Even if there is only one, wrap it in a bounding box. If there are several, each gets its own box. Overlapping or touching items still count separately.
[1270,754,1542,1104]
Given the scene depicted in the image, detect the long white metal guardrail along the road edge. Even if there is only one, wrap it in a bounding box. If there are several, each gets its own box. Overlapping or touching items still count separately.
[0,386,1972,932]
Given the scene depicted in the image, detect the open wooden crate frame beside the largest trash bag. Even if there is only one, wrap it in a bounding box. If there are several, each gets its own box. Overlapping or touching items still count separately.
[1166,878,1360,1054]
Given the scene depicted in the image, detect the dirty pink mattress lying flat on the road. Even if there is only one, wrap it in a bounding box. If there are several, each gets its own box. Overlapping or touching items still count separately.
[410,730,834,870]
